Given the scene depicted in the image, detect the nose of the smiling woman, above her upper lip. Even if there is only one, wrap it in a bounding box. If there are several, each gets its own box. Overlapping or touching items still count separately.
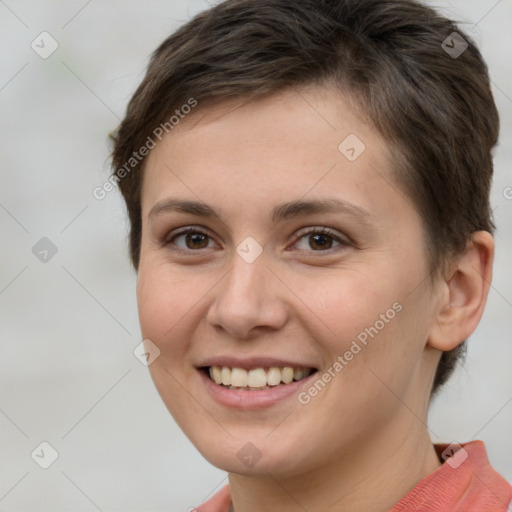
[207,249,288,339]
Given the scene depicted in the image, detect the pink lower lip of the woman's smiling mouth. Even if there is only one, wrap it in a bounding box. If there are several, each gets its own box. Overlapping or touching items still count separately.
[198,370,316,409]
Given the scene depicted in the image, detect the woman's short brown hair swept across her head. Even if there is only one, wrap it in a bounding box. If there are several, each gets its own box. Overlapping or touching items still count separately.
[112,0,499,391]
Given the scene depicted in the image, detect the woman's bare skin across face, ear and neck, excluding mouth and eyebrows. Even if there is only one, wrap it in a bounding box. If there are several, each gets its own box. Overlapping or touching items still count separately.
[137,87,493,512]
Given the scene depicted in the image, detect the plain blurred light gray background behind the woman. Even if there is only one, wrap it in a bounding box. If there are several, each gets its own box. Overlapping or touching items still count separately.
[0,0,512,511]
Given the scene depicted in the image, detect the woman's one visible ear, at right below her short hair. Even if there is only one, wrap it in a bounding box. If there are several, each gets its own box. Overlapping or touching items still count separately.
[428,231,494,351]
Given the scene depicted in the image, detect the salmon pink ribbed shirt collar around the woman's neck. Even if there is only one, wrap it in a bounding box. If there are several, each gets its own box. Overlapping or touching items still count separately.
[195,441,512,512]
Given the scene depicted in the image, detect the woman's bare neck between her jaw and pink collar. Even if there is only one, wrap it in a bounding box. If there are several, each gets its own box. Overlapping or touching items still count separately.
[229,421,441,512]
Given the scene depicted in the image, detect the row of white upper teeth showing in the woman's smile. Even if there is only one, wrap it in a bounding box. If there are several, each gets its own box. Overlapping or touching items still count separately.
[210,366,311,388]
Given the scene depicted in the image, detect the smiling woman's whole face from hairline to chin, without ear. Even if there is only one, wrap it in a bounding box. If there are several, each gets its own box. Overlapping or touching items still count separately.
[137,88,436,476]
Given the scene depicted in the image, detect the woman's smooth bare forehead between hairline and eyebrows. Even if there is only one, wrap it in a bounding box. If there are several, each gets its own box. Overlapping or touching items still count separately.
[142,87,412,227]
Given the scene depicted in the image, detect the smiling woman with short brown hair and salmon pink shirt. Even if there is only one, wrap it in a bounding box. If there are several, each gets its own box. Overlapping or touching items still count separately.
[112,0,512,512]
